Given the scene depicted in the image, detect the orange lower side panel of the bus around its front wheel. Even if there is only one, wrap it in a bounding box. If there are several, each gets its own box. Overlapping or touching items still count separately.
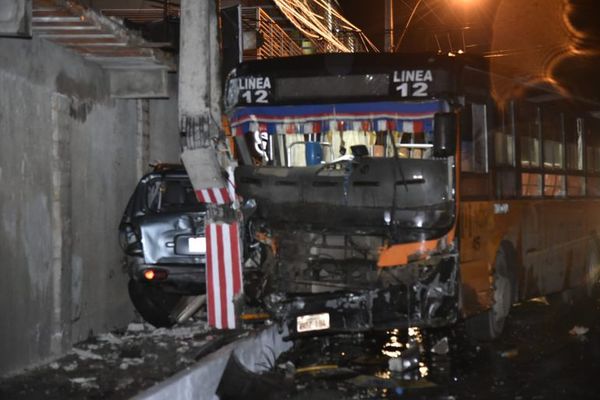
[460,199,600,315]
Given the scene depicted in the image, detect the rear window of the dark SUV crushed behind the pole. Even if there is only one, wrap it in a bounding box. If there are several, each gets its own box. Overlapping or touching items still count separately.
[146,178,200,212]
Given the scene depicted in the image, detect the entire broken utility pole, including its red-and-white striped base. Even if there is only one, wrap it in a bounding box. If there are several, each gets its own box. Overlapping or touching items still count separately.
[179,0,243,329]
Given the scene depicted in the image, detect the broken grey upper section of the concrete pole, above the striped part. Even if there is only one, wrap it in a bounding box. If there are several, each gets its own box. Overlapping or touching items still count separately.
[179,0,229,191]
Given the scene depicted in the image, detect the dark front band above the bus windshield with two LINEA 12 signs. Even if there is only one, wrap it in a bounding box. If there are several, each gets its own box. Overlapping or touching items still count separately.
[225,53,481,110]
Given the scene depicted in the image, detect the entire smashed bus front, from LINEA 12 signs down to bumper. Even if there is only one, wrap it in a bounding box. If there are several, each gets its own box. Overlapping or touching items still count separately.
[226,54,460,337]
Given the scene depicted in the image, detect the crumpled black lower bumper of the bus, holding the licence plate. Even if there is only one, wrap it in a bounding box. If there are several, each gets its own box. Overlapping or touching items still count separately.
[271,255,458,338]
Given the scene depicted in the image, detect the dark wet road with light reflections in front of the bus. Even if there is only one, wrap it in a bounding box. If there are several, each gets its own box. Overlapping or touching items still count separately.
[220,299,600,400]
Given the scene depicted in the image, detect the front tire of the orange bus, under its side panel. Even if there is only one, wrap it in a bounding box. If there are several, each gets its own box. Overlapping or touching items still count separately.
[465,247,515,341]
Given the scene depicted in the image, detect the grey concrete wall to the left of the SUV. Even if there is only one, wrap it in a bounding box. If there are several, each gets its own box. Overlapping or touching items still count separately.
[0,34,179,376]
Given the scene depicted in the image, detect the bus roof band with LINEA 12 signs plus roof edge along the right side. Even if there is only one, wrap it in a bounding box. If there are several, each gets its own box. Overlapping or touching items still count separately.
[225,53,600,111]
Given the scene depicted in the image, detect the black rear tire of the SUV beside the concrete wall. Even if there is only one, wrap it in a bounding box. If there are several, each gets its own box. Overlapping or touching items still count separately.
[128,279,183,328]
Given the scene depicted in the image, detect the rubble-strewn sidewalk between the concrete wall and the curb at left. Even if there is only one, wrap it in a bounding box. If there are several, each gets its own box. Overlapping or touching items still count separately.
[0,319,213,400]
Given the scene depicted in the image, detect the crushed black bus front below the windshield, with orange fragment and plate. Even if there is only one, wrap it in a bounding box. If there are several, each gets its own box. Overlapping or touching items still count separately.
[236,156,458,336]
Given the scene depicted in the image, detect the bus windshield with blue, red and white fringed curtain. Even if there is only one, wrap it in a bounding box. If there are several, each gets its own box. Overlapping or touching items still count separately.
[231,100,447,167]
